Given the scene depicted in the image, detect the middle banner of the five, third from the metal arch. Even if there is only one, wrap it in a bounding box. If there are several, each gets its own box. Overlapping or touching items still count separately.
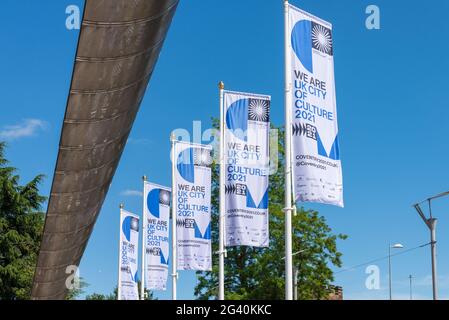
[173,142,212,271]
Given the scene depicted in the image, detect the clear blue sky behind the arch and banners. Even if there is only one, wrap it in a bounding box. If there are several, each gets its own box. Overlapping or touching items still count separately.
[0,0,449,299]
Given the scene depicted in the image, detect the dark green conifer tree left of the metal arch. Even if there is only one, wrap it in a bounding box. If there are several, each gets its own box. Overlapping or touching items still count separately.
[0,143,46,300]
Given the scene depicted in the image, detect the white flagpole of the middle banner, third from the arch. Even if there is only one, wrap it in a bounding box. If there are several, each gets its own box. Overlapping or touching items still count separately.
[170,133,178,300]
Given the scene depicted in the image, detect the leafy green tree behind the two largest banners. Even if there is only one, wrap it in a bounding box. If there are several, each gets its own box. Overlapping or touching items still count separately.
[195,120,346,300]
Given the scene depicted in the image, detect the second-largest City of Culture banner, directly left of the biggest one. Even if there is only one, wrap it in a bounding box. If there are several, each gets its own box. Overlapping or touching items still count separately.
[224,91,271,247]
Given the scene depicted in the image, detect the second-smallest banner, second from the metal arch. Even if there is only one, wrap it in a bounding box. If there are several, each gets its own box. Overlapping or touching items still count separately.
[143,182,171,290]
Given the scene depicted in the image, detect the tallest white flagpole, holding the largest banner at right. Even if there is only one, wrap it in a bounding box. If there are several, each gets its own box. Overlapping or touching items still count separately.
[284,0,293,300]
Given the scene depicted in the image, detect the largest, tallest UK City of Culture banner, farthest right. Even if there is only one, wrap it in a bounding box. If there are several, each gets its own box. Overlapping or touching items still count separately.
[287,6,343,207]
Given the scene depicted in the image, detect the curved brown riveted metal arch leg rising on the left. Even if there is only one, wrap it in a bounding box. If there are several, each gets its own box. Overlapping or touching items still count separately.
[32,0,179,299]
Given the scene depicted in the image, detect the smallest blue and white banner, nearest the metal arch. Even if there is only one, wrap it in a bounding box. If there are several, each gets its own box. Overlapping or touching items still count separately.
[118,210,139,300]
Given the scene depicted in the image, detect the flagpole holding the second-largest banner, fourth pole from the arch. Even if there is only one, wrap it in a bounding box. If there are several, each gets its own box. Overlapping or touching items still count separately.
[218,81,226,300]
